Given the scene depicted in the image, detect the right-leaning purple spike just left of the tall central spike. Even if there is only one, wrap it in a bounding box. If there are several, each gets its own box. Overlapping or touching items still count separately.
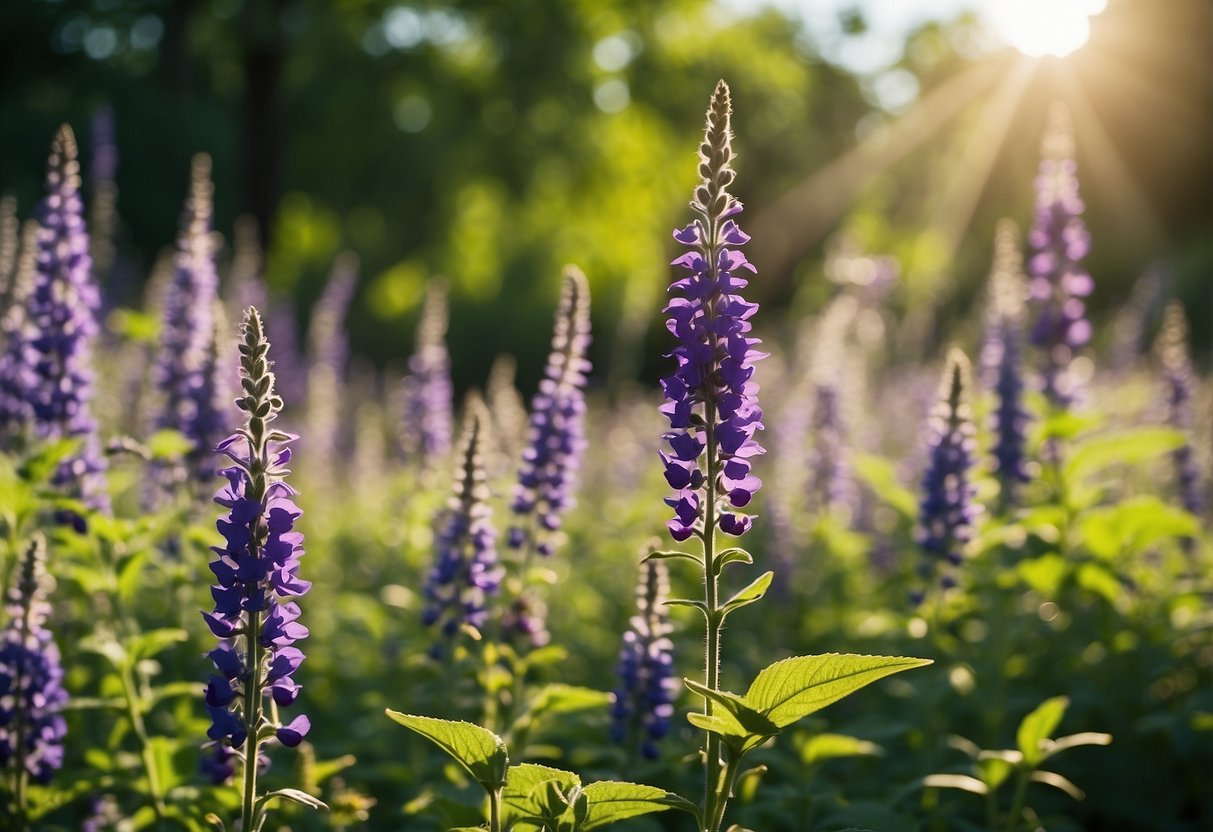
[509,266,590,555]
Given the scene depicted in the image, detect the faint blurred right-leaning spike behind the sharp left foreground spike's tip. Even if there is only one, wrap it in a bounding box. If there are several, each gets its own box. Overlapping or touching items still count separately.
[307,251,358,472]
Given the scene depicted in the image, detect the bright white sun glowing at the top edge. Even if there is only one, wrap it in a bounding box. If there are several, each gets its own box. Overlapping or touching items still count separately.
[990,0,1107,58]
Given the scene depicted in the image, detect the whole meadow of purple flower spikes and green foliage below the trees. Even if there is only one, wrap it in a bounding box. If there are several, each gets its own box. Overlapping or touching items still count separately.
[0,81,1213,832]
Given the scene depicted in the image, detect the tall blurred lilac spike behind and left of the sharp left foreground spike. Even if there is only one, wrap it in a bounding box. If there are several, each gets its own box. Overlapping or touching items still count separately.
[154,153,226,483]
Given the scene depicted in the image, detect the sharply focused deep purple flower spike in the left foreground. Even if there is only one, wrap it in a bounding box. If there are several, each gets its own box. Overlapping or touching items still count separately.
[203,307,312,782]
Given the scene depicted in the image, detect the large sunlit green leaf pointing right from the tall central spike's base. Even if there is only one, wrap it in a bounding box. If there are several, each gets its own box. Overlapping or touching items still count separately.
[745,653,932,728]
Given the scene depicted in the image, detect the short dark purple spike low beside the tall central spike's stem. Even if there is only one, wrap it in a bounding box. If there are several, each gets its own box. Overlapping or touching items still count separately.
[610,560,678,759]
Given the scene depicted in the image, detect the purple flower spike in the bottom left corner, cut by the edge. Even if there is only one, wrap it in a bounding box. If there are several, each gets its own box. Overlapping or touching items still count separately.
[0,537,68,785]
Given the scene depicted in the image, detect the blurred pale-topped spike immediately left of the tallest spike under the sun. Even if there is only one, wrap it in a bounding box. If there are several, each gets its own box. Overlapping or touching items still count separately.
[981,220,1029,509]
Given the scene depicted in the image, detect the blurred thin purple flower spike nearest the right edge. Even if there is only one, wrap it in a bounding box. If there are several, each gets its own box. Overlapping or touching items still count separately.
[1155,302,1205,517]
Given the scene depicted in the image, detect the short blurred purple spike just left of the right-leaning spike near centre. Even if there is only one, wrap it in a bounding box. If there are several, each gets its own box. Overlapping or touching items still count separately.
[422,395,503,655]
